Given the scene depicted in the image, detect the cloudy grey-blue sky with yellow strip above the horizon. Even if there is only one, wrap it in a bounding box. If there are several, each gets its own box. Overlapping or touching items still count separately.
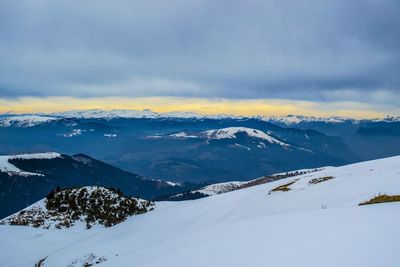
[0,0,400,117]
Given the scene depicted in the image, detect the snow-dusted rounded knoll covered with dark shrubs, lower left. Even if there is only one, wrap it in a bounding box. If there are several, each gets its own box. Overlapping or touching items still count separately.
[0,186,154,229]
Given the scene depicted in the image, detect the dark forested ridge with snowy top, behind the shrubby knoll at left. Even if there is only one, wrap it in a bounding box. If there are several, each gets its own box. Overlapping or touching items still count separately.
[0,153,197,218]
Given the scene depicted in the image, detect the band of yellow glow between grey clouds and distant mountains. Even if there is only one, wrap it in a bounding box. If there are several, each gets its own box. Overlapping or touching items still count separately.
[0,97,396,118]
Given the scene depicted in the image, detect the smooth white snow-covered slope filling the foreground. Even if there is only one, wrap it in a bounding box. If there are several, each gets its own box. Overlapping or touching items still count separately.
[0,156,400,267]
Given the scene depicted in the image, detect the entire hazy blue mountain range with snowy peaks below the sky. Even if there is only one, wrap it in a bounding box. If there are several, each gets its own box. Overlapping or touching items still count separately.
[0,110,400,183]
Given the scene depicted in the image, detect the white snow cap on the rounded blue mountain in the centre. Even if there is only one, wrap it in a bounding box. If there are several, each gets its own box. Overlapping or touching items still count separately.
[204,127,290,146]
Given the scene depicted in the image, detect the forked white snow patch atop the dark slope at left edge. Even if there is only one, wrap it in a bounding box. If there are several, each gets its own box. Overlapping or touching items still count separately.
[0,152,61,176]
